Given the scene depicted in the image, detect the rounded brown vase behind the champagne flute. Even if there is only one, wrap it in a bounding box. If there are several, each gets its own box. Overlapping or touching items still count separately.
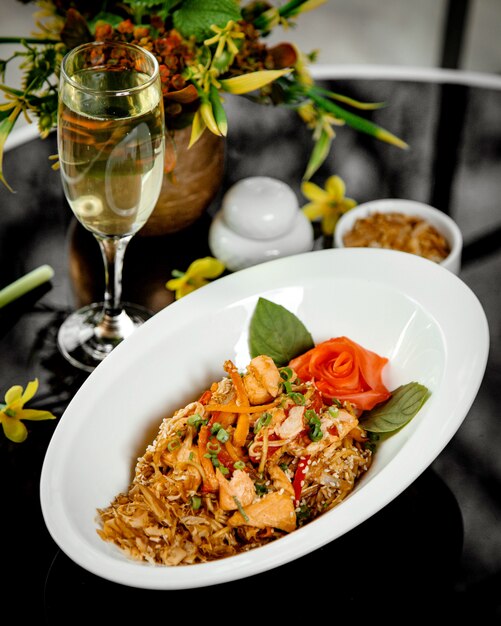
[138,126,225,236]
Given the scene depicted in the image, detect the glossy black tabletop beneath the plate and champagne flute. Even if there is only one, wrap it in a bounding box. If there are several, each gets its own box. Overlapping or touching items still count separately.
[0,73,501,624]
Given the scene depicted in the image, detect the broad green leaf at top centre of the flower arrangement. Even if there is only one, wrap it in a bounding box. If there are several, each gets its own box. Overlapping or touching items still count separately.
[173,0,241,42]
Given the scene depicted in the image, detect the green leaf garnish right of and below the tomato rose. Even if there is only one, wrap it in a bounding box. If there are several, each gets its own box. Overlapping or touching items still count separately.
[360,382,431,433]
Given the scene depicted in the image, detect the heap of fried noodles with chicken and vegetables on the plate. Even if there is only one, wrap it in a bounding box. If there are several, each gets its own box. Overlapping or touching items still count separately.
[97,356,372,565]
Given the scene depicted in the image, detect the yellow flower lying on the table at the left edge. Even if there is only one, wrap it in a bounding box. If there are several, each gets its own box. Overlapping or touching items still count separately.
[0,378,56,443]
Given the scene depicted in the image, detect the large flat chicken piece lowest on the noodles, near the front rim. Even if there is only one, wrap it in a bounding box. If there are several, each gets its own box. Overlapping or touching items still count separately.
[228,491,296,533]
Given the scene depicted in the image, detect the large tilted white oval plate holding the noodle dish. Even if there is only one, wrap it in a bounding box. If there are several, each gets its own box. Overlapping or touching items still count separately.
[40,248,489,589]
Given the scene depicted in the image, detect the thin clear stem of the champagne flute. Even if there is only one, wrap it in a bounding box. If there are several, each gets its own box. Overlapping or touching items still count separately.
[96,235,133,341]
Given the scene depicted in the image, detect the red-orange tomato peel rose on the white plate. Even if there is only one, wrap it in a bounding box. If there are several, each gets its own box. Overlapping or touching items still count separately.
[289,337,391,411]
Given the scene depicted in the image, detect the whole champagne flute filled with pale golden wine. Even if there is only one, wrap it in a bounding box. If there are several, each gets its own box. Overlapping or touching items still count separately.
[57,41,165,372]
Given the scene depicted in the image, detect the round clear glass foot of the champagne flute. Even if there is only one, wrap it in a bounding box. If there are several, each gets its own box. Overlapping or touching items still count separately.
[57,302,152,372]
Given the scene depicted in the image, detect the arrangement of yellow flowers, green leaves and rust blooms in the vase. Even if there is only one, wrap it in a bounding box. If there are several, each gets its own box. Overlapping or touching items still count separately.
[0,0,406,186]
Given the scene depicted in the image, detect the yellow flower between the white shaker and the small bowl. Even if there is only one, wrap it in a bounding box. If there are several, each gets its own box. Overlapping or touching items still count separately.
[301,176,357,235]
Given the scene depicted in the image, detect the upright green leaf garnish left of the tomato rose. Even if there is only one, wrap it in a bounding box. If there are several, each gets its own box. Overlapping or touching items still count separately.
[249,298,315,367]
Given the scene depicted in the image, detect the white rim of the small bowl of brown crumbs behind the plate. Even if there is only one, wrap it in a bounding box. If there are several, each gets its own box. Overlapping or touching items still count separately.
[334,198,463,274]
